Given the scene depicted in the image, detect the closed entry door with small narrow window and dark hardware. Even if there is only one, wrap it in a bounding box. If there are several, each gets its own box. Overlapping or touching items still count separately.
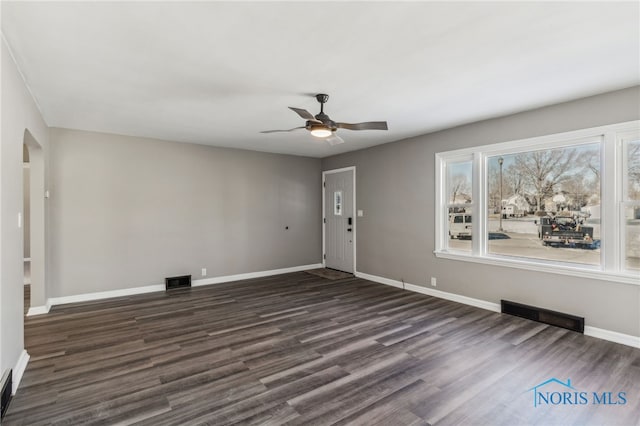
[324,169,355,273]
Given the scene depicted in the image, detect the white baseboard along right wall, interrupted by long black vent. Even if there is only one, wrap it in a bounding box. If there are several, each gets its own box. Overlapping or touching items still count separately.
[355,272,640,348]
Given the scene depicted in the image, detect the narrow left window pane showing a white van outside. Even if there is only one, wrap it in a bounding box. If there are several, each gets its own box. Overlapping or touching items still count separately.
[447,161,473,251]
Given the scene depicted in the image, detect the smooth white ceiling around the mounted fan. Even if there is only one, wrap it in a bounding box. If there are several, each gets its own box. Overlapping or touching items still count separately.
[2,1,640,157]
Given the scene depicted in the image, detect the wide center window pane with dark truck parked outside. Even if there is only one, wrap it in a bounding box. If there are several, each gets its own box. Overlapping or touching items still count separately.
[487,143,600,265]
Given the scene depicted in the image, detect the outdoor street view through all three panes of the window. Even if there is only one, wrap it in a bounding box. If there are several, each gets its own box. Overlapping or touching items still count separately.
[447,140,640,269]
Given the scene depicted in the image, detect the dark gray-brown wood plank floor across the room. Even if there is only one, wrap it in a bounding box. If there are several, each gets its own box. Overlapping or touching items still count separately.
[3,272,640,426]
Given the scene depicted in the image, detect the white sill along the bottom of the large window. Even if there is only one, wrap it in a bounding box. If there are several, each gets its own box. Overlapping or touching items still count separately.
[433,250,640,286]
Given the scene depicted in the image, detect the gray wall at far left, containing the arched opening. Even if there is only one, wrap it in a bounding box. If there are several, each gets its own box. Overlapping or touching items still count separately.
[0,39,48,378]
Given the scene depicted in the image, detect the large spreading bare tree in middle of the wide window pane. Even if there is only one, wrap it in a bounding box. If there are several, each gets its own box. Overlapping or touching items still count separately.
[516,148,577,211]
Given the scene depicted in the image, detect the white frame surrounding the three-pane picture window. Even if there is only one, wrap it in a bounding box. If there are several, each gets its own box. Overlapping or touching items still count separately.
[434,120,640,285]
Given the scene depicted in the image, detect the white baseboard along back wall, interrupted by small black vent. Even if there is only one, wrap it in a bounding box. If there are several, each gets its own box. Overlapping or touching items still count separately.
[44,263,322,308]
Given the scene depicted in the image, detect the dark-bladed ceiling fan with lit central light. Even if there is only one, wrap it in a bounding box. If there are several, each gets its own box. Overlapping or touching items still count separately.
[260,93,388,145]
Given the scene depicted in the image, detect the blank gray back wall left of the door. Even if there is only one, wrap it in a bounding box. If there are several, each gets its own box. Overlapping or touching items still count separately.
[49,129,322,297]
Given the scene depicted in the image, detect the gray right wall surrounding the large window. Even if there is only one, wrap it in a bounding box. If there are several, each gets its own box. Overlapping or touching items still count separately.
[322,87,640,336]
